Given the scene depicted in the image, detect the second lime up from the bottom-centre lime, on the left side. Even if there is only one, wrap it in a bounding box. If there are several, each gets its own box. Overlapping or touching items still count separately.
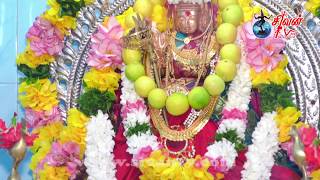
[134,76,156,98]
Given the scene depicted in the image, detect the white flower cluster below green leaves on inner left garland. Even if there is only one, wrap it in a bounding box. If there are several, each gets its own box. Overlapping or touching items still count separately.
[127,131,159,154]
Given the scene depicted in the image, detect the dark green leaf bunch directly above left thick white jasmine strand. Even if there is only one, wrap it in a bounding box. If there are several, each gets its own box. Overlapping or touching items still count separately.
[78,89,116,117]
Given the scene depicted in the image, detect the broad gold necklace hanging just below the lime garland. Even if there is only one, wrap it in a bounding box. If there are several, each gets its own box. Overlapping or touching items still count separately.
[149,97,219,141]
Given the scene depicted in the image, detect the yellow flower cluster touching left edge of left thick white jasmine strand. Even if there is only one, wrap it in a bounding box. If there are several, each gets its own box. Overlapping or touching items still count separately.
[60,108,89,157]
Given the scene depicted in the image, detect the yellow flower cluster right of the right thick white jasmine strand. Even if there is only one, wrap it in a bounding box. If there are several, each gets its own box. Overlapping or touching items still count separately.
[275,107,301,143]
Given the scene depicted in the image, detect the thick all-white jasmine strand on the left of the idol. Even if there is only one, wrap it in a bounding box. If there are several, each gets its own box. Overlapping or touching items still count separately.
[84,110,116,180]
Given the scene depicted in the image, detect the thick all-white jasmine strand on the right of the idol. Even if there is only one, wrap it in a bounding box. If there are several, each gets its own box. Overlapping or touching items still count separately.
[241,112,279,180]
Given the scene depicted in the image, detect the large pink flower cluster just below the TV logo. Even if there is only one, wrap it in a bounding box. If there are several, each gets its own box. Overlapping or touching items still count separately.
[240,22,285,72]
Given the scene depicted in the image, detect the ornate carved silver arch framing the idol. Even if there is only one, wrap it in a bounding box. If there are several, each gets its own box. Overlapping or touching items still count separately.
[51,0,320,131]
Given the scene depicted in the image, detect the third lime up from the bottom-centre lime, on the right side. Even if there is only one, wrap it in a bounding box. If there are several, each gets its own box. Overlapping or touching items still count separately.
[215,59,237,82]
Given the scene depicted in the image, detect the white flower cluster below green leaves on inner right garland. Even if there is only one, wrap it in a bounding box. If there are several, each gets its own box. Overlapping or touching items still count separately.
[205,139,238,169]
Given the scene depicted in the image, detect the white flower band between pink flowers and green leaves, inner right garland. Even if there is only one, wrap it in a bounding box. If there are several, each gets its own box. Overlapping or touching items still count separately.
[217,119,246,139]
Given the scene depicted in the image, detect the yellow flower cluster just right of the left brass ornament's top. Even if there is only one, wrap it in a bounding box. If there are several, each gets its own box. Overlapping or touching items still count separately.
[31,121,63,153]
